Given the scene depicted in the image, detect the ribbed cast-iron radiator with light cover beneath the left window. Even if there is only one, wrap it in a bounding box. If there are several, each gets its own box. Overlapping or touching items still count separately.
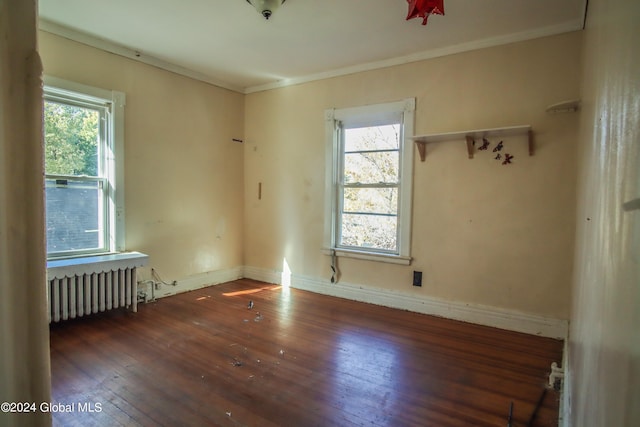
[47,252,147,323]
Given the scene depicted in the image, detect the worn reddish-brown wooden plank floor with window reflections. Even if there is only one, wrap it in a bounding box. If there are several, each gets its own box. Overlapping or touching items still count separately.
[51,280,562,427]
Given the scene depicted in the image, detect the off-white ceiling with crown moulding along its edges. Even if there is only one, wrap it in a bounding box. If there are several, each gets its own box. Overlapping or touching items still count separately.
[39,0,586,93]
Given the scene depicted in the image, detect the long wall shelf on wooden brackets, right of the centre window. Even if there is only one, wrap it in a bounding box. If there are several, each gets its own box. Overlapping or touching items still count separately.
[411,125,535,162]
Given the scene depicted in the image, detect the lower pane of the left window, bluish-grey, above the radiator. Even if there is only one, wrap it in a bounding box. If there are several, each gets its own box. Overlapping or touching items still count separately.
[46,179,104,252]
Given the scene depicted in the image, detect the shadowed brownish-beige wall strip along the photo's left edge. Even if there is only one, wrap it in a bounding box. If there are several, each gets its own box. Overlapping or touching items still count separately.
[0,1,51,427]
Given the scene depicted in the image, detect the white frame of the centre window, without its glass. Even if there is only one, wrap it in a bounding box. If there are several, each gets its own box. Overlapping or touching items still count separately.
[324,98,416,265]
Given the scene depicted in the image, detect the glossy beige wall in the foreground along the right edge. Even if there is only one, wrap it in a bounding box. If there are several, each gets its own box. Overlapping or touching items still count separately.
[565,0,640,427]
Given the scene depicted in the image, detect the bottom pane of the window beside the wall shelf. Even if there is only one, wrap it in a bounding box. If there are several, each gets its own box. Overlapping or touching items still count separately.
[340,214,397,251]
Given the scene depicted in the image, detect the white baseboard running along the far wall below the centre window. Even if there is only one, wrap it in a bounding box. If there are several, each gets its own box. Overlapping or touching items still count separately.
[243,267,568,340]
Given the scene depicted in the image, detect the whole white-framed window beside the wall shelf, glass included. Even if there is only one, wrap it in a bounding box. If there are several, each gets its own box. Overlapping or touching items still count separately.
[325,99,415,264]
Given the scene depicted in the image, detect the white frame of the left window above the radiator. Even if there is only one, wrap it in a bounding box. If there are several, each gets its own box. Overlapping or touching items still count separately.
[44,76,126,259]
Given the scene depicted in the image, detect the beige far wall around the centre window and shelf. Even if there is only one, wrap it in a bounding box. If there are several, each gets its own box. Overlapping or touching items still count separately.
[244,33,581,319]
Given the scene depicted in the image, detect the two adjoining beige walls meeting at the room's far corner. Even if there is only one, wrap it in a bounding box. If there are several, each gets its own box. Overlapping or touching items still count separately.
[40,32,581,319]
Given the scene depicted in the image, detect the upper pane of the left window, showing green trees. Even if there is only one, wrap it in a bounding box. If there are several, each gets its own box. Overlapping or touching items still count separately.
[44,101,100,176]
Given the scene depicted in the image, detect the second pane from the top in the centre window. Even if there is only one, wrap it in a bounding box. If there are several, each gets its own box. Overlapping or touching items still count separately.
[344,151,399,184]
